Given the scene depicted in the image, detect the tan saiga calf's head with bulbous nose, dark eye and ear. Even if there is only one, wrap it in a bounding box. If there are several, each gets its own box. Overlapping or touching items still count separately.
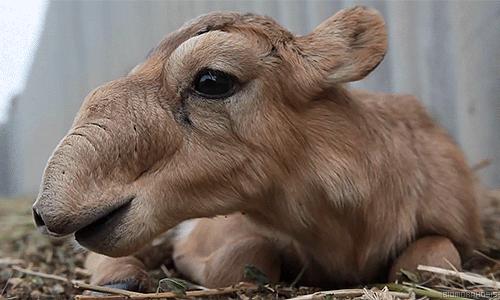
[33,7,386,256]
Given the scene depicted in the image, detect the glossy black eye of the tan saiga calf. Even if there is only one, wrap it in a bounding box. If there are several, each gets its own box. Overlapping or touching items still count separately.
[194,69,237,99]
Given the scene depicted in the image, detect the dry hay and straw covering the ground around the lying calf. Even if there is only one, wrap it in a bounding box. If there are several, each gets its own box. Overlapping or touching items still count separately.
[0,196,500,300]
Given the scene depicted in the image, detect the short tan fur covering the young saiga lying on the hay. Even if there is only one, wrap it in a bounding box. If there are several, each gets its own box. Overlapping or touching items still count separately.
[34,7,490,286]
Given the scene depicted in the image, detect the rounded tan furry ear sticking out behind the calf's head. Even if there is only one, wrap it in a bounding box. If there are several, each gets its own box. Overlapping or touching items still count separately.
[296,6,387,83]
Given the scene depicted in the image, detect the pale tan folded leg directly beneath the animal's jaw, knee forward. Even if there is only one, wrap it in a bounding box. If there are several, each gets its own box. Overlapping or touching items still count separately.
[174,215,281,287]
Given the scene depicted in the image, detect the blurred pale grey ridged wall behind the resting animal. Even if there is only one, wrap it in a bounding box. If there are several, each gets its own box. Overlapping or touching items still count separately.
[0,0,500,197]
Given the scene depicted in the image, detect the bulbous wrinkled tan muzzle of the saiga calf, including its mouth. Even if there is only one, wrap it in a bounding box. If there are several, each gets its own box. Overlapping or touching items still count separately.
[33,79,180,255]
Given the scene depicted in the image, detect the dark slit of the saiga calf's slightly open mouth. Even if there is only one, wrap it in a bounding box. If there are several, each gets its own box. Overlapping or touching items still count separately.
[75,197,135,245]
